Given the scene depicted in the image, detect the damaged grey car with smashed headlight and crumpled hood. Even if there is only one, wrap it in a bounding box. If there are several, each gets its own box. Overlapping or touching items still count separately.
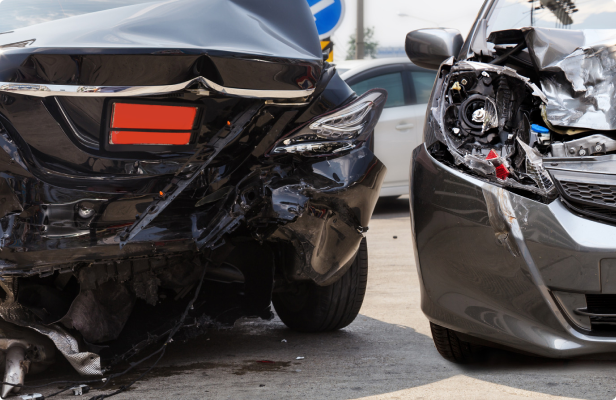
[406,0,616,362]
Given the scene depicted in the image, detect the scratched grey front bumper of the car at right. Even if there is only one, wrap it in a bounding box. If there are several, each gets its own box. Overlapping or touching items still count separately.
[410,144,616,357]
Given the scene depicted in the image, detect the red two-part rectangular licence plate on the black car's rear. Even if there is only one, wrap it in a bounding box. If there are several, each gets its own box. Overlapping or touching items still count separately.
[109,103,198,146]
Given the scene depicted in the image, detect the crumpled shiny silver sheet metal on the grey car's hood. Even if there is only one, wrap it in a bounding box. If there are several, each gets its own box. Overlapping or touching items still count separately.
[522,28,616,130]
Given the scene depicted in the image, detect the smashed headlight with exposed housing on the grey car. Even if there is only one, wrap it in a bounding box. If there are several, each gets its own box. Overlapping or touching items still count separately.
[426,61,556,199]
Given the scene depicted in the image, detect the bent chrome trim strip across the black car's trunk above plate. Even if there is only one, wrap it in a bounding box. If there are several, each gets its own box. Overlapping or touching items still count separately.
[0,76,314,99]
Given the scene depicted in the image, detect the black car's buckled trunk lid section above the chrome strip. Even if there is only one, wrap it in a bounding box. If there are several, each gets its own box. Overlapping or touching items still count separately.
[0,0,323,90]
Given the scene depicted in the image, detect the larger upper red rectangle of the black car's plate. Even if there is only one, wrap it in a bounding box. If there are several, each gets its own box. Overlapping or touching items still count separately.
[111,103,197,130]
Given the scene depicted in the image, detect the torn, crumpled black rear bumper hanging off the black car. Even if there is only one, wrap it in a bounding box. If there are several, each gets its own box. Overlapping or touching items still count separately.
[0,136,386,285]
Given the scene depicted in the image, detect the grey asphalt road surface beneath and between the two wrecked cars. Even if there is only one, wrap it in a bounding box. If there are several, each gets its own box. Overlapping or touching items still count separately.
[27,197,616,400]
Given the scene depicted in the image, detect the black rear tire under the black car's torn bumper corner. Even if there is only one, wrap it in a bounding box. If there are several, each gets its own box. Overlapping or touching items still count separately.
[272,238,368,332]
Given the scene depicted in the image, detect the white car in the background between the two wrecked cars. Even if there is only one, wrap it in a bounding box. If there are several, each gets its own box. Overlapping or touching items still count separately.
[336,57,436,197]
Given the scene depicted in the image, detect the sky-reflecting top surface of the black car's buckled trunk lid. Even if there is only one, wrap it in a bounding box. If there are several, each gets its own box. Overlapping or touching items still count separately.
[0,0,323,62]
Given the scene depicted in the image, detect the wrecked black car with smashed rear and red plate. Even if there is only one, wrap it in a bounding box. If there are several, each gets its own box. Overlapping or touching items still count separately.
[0,0,387,397]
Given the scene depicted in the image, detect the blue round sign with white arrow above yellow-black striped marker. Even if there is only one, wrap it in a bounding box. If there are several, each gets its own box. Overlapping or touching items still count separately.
[308,0,344,62]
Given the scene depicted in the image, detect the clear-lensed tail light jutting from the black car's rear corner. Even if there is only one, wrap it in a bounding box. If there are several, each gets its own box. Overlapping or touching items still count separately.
[270,89,387,157]
